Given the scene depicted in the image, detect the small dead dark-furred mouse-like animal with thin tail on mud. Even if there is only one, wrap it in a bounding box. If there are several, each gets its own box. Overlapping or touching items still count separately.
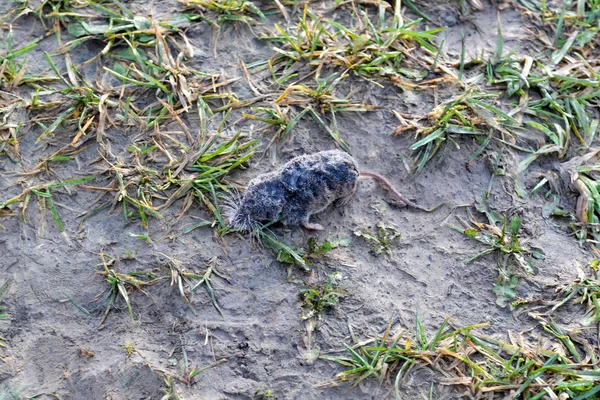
[224,150,437,231]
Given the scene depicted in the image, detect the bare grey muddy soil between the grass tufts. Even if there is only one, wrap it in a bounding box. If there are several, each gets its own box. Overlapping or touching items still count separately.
[0,1,592,399]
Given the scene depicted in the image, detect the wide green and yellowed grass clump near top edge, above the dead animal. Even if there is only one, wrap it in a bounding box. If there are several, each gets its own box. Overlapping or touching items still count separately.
[262,3,442,85]
